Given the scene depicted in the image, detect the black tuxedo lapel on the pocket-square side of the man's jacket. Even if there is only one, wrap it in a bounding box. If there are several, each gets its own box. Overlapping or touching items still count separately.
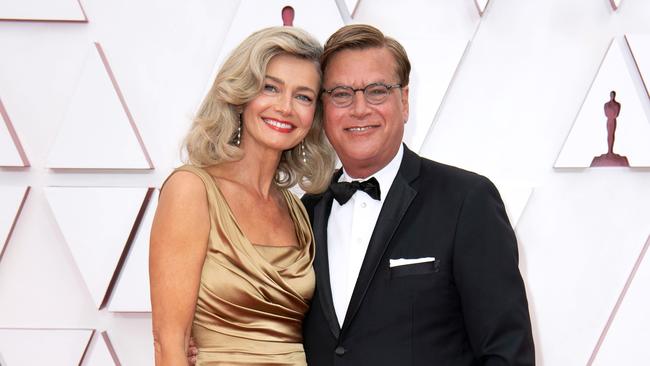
[340,146,420,329]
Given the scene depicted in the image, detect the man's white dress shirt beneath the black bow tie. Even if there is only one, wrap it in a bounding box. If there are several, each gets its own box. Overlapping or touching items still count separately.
[327,145,404,326]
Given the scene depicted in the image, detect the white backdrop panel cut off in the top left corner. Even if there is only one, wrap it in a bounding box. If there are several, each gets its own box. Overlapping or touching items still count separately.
[0,0,88,23]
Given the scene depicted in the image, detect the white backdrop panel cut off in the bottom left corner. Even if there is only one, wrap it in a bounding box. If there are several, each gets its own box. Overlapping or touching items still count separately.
[0,328,94,366]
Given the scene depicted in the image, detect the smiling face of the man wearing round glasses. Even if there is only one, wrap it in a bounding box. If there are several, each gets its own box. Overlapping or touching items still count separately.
[323,48,409,178]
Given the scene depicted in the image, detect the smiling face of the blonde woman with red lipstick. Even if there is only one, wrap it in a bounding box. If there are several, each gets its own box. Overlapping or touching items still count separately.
[240,54,320,151]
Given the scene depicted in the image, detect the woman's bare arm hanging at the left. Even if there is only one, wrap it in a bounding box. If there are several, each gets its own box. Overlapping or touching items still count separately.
[149,171,210,366]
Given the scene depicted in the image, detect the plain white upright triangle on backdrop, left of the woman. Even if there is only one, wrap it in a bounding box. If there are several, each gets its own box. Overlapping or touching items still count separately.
[47,43,153,169]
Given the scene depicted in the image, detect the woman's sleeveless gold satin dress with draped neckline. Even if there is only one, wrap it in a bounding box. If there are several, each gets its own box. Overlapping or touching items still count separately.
[172,165,315,366]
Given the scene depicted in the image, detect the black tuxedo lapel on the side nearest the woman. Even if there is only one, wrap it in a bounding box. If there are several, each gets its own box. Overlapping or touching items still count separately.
[313,173,341,339]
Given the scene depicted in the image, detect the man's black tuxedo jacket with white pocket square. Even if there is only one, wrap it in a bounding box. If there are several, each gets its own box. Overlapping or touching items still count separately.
[303,148,535,366]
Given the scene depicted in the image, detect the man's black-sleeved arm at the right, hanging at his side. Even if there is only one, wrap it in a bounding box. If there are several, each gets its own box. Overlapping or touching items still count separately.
[453,177,535,366]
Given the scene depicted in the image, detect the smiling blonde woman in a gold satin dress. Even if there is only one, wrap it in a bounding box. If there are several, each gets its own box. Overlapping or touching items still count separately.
[150,27,334,366]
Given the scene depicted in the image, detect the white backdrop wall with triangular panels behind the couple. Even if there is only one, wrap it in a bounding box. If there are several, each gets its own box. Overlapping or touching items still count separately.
[0,0,650,366]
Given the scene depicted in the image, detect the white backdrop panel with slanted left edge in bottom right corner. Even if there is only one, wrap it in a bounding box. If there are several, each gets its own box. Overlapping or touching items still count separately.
[591,234,650,366]
